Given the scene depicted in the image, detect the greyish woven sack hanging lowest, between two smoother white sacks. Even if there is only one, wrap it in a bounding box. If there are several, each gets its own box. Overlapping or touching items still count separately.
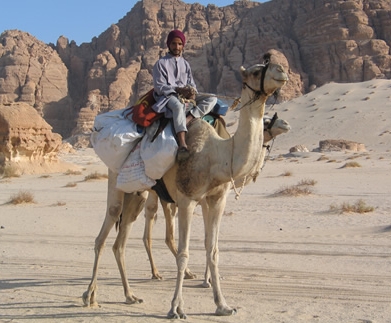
[117,143,156,193]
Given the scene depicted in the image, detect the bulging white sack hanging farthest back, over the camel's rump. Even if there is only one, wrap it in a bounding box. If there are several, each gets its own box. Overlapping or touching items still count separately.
[90,109,145,173]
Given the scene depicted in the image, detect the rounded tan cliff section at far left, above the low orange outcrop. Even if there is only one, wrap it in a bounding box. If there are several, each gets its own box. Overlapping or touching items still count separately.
[0,30,75,139]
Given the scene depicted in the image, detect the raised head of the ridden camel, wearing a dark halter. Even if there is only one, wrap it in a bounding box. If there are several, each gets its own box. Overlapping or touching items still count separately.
[240,54,288,97]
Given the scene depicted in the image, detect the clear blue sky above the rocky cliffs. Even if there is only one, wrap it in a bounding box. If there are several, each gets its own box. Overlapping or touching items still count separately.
[0,0,265,45]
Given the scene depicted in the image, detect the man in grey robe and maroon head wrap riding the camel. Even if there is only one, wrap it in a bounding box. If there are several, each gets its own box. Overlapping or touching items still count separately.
[153,30,217,160]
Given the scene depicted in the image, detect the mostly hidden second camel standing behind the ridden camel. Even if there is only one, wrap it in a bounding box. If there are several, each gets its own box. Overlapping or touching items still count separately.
[143,114,291,287]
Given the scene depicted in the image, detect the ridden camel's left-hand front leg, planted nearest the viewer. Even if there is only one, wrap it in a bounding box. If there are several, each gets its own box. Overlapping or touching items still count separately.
[167,193,197,319]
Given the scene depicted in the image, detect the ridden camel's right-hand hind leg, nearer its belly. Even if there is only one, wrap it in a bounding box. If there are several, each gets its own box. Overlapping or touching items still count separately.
[113,191,148,304]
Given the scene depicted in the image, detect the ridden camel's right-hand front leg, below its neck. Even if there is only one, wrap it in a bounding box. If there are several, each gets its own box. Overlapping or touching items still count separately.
[204,193,237,316]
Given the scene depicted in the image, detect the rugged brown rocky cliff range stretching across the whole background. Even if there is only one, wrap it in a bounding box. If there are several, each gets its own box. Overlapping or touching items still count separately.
[0,0,391,143]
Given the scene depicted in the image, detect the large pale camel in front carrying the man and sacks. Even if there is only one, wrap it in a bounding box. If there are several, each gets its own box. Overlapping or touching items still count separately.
[83,55,288,319]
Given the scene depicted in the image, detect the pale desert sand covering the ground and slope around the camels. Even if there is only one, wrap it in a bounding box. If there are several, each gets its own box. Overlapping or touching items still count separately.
[0,80,391,323]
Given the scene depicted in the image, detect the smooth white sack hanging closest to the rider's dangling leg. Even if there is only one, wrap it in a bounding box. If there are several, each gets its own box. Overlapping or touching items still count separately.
[140,123,178,179]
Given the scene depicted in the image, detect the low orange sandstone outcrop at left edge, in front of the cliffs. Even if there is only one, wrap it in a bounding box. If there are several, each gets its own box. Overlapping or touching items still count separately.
[0,102,62,165]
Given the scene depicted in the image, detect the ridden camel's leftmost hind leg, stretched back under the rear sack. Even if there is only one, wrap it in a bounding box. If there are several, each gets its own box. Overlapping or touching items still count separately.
[82,170,124,307]
